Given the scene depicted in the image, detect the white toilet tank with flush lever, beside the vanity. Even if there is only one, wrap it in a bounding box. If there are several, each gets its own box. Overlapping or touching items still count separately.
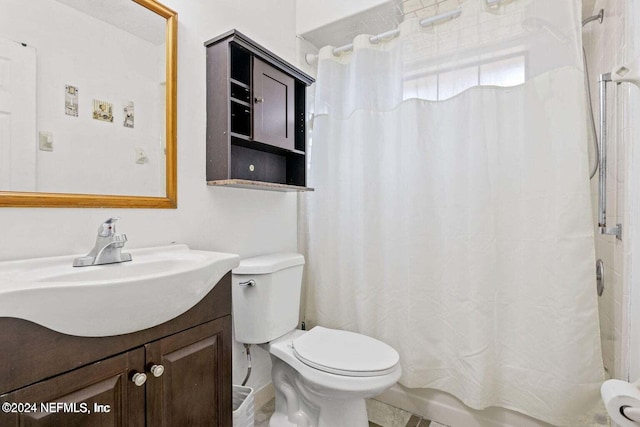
[231,253,304,344]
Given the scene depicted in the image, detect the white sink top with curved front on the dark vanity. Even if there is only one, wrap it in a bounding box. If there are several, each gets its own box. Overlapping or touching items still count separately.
[0,245,240,337]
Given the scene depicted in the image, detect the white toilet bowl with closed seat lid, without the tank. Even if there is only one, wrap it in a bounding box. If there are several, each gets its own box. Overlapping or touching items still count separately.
[263,327,402,427]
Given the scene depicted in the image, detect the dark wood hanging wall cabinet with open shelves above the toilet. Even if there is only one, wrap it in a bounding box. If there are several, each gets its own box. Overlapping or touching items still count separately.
[205,30,313,191]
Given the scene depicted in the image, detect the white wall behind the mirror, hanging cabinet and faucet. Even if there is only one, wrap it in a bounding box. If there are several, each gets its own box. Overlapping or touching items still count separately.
[0,0,297,394]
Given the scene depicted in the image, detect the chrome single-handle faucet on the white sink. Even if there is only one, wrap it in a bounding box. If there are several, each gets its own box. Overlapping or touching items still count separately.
[73,217,131,267]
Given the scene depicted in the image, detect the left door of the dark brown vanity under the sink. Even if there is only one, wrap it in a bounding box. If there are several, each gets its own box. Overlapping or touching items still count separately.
[0,348,145,427]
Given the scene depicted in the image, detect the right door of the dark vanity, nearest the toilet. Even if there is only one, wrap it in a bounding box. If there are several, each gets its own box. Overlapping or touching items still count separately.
[147,316,232,427]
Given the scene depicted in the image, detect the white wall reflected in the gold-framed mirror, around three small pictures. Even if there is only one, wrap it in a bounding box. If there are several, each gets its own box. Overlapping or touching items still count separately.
[0,0,165,196]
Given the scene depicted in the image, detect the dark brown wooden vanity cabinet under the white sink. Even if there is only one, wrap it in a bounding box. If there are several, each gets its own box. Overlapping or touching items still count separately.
[0,274,233,427]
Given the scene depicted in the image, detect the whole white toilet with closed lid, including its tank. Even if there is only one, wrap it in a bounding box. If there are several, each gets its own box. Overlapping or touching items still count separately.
[232,253,401,427]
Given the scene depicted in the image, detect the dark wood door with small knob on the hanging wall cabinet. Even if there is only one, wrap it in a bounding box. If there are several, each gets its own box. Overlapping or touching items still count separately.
[253,58,295,150]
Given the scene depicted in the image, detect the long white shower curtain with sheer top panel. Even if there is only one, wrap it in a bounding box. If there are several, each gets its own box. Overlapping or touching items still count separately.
[306,0,603,427]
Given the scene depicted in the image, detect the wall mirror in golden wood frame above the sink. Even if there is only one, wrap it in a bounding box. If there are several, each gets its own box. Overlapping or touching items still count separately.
[0,0,177,208]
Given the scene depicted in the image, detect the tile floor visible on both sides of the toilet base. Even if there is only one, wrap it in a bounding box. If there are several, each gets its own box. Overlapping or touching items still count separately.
[255,399,447,427]
